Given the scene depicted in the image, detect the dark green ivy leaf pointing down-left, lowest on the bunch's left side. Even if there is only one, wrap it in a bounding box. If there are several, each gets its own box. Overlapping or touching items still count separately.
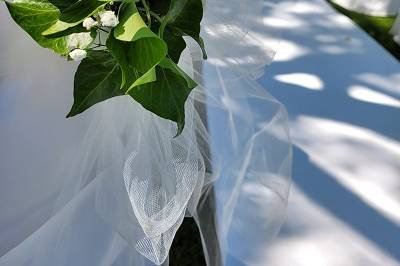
[67,50,124,117]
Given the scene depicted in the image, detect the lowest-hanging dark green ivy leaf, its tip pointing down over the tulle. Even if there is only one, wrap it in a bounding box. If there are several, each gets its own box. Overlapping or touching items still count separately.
[129,58,197,136]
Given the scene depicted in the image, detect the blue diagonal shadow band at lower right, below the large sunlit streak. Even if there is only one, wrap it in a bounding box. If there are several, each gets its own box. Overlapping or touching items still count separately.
[294,149,400,260]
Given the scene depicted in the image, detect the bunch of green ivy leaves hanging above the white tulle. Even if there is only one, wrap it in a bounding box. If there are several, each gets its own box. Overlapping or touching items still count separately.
[4,0,206,135]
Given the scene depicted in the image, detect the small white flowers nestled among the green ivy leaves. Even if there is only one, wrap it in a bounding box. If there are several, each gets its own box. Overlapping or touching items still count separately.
[69,10,119,61]
